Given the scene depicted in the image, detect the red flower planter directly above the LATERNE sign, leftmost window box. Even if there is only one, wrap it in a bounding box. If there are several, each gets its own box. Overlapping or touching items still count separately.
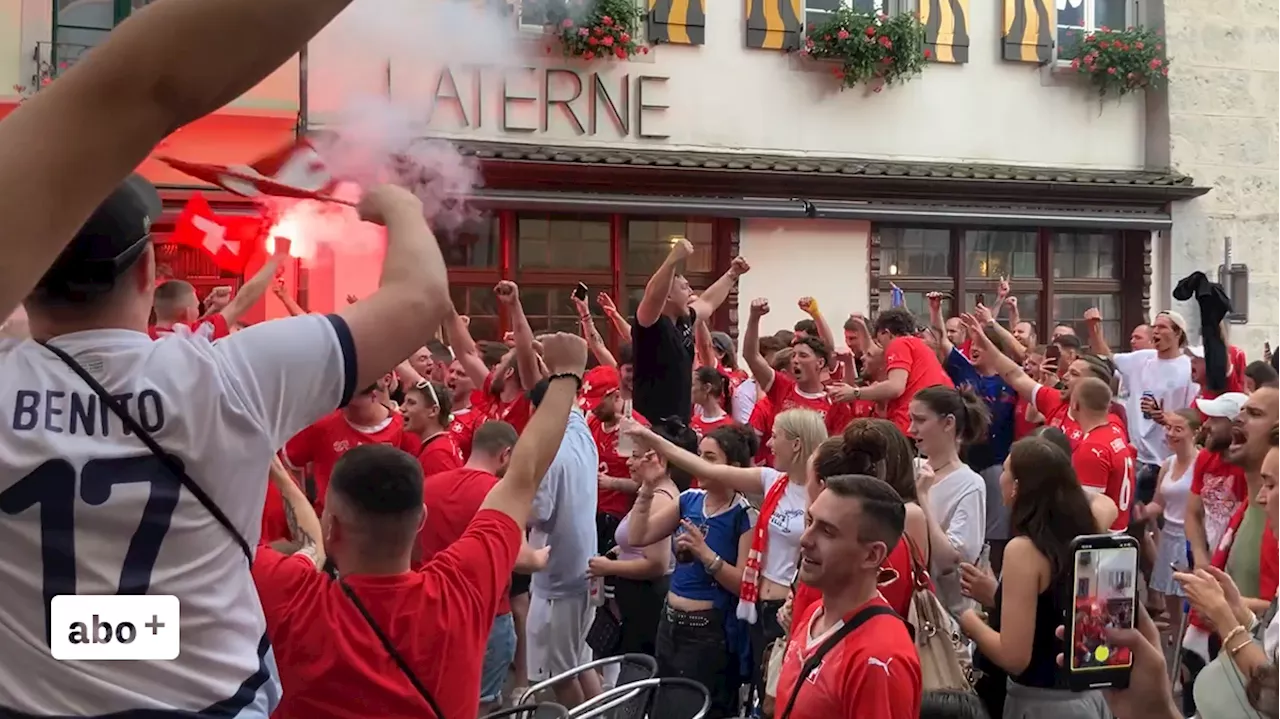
[526,0,649,60]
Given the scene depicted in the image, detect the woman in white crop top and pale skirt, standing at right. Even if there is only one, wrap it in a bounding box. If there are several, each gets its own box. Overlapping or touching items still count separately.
[1140,409,1201,627]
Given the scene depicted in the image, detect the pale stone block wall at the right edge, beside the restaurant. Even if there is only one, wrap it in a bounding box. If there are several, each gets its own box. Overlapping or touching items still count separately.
[1172,0,1280,360]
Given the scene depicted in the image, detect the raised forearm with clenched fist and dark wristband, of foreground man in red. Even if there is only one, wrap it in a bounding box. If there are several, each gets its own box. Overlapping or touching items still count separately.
[481,333,586,530]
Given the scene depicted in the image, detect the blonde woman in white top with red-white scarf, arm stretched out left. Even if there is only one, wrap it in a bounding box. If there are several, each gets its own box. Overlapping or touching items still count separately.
[622,409,827,696]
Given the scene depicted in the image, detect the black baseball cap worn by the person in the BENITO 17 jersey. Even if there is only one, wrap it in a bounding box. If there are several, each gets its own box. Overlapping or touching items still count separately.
[36,174,161,296]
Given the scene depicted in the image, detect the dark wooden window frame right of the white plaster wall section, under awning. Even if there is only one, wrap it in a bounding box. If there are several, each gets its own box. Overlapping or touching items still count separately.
[868,223,1151,343]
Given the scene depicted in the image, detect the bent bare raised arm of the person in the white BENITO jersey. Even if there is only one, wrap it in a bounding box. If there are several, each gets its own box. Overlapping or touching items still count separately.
[337,185,452,388]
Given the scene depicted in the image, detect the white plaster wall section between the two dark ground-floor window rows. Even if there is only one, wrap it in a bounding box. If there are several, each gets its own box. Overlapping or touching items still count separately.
[737,220,870,338]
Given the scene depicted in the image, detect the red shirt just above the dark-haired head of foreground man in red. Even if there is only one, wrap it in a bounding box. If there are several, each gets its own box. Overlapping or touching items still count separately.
[284,409,421,514]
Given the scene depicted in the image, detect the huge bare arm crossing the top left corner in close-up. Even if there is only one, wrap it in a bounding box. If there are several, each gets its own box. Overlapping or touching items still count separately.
[0,0,351,317]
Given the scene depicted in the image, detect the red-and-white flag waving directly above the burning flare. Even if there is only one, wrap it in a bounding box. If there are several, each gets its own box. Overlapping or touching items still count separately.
[160,139,338,201]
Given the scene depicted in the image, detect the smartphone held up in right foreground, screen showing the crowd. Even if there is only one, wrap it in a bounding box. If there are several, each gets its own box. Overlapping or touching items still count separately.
[1065,535,1138,692]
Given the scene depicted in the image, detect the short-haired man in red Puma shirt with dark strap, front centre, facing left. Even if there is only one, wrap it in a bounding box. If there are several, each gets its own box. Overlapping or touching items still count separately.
[776,475,923,719]
